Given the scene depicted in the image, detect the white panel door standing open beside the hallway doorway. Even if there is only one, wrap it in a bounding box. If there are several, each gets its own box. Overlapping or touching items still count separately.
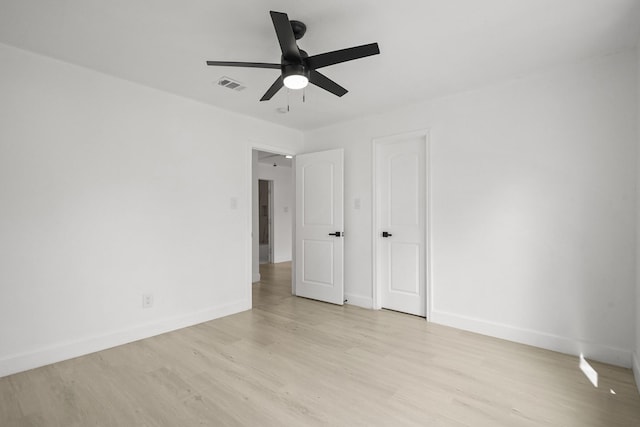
[295,149,344,305]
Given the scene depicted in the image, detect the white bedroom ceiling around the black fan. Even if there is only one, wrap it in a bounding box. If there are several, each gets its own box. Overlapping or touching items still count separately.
[0,0,640,130]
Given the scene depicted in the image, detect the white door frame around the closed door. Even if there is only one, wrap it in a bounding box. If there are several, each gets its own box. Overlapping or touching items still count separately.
[371,129,433,321]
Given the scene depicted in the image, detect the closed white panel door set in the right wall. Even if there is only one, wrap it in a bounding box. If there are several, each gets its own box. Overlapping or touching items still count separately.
[376,135,426,316]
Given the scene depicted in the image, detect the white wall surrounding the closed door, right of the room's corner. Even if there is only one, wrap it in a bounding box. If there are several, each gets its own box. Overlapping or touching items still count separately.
[305,51,637,366]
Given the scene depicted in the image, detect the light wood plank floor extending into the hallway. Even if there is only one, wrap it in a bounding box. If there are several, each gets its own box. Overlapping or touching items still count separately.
[0,264,640,427]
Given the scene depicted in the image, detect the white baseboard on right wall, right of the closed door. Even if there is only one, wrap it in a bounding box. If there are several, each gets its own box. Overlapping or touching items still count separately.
[431,310,633,368]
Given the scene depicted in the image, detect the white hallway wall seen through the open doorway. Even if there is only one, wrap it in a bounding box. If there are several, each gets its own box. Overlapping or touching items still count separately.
[258,163,294,262]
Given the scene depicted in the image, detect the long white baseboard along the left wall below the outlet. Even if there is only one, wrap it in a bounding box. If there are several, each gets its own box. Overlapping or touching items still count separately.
[0,301,251,378]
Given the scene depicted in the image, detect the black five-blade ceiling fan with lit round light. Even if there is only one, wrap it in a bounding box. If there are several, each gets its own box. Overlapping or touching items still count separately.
[207,11,380,101]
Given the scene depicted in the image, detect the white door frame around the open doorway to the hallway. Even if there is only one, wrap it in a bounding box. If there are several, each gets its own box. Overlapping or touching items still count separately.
[245,140,297,310]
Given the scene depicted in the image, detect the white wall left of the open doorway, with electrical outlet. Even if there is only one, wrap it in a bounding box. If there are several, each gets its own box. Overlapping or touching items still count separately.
[0,45,302,376]
